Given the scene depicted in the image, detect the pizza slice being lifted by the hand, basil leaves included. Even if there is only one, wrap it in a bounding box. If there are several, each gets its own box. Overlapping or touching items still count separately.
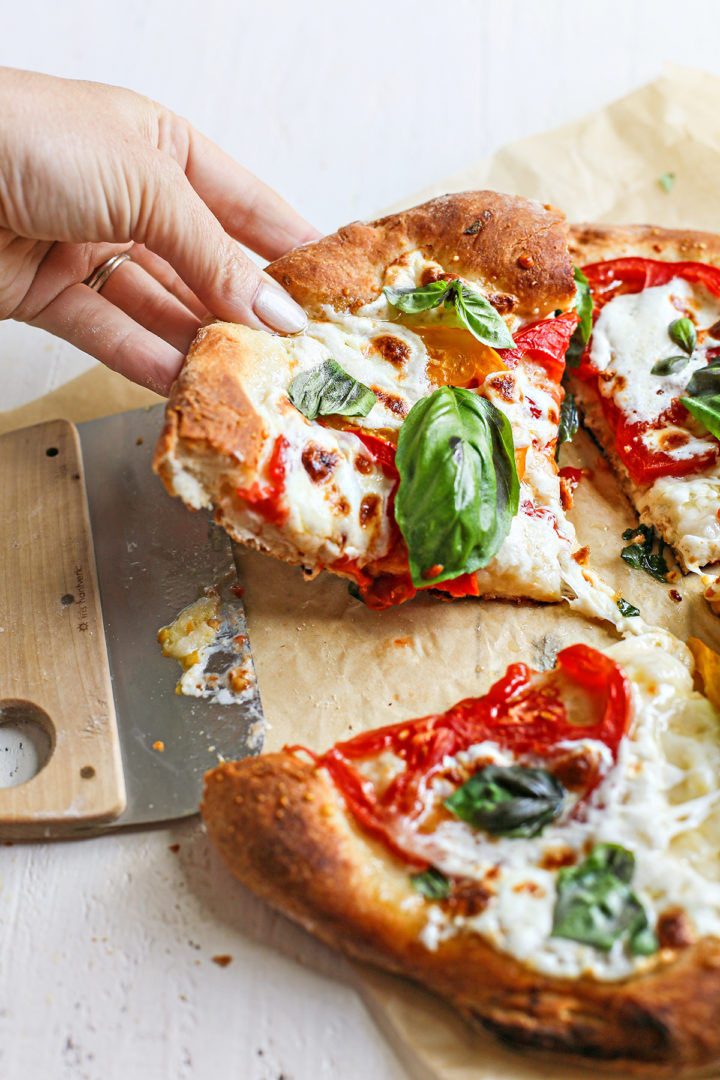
[154,191,623,625]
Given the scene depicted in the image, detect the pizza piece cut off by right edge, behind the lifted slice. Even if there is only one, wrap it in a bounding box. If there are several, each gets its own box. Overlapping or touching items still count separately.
[570,226,720,603]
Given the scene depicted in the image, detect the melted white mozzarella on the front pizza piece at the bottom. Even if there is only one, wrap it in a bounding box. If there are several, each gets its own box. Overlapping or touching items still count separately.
[406,632,720,980]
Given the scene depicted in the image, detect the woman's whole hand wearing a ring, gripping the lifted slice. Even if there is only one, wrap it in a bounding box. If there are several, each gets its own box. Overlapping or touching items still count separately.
[0,68,318,393]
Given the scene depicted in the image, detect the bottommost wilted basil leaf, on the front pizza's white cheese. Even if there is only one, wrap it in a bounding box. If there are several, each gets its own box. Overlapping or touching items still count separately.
[552,843,657,954]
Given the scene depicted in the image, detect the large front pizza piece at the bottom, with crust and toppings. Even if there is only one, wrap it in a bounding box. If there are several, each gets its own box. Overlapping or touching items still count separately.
[201,631,720,1076]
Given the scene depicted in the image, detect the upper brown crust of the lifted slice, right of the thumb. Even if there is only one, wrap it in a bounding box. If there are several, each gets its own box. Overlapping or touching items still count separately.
[268,191,574,319]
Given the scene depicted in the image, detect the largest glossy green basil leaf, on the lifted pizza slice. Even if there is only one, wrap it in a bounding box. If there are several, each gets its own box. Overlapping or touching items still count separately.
[395,387,520,588]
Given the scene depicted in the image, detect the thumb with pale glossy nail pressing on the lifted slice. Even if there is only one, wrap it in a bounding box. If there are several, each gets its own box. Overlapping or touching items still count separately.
[132,151,308,334]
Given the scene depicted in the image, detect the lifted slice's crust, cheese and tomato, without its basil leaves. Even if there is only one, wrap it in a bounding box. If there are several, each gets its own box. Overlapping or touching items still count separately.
[155,192,616,616]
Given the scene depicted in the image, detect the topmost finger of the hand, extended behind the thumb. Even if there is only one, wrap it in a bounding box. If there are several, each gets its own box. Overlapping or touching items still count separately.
[180,125,321,259]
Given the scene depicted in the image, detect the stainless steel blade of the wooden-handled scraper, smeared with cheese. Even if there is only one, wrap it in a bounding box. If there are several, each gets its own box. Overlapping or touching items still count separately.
[78,405,262,828]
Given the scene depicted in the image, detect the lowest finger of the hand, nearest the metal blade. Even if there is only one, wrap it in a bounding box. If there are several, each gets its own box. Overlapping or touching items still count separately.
[30,282,184,396]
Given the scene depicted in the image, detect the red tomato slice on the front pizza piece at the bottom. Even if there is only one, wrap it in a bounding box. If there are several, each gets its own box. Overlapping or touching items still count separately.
[316,645,631,862]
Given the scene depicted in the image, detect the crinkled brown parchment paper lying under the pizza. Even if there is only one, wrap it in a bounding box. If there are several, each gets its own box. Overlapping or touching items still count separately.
[0,61,720,1080]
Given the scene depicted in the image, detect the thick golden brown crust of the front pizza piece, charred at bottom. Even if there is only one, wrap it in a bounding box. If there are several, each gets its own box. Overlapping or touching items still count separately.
[201,753,720,1075]
